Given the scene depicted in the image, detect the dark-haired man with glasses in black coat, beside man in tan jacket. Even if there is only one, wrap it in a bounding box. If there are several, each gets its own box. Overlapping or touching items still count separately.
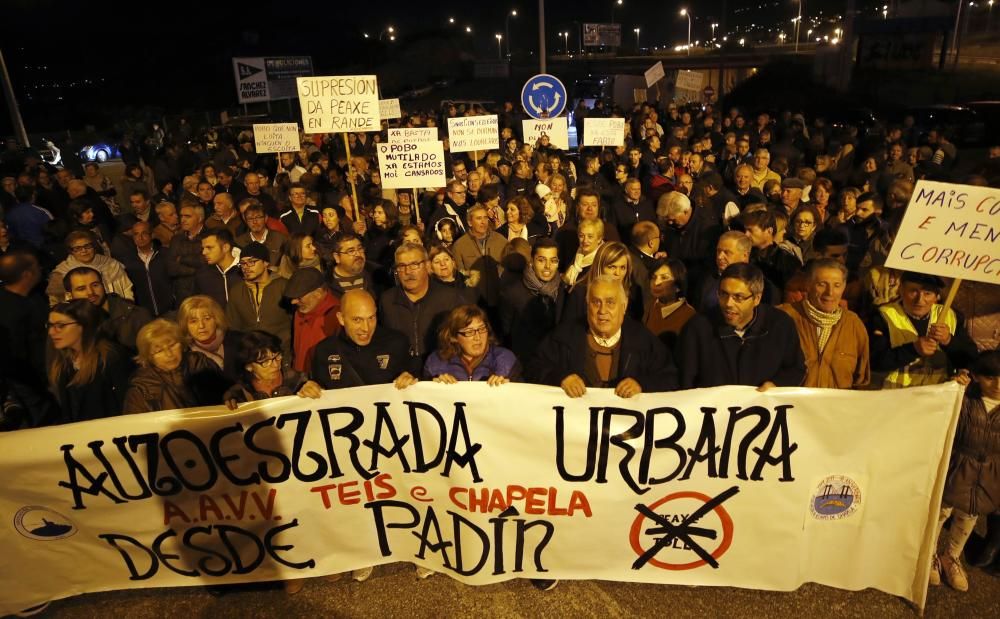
[678,263,806,391]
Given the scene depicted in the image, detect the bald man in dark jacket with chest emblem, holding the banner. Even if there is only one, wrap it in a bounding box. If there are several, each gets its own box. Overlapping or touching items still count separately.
[311,288,420,389]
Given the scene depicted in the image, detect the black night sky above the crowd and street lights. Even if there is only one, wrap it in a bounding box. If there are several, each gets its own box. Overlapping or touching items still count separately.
[0,0,874,134]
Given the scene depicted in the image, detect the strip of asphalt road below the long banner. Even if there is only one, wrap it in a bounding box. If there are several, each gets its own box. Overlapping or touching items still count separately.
[27,563,1000,619]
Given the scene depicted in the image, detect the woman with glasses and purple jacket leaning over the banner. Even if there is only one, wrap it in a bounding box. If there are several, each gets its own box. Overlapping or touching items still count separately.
[424,305,521,387]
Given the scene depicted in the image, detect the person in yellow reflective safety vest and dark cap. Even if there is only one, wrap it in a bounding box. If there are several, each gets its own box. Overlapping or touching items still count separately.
[869,272,976,389]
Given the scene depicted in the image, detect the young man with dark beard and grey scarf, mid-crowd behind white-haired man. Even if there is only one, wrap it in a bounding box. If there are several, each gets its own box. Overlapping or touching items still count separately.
[500,237,566,361]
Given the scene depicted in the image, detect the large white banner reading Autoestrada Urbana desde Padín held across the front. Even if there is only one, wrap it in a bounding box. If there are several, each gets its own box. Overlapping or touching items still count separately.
[0,381,963,614]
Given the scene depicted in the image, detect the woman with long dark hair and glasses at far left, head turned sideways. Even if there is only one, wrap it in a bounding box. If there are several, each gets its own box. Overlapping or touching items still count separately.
[46,299,134,423]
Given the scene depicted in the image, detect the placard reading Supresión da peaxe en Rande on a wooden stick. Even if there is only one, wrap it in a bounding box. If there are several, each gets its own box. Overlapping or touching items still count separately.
[295,75,382,133]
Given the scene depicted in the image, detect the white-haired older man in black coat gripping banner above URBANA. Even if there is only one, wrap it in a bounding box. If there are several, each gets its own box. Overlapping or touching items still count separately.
[529,275,677,398]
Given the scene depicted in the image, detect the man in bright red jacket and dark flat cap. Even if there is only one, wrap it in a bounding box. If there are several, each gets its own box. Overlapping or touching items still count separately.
[284,269,340,372]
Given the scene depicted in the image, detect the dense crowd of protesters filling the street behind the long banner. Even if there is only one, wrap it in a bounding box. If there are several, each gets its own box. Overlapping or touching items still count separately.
[0,95,1000,590]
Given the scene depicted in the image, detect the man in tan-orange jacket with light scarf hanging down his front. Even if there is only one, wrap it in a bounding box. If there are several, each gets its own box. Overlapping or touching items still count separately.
[778,258,871,389]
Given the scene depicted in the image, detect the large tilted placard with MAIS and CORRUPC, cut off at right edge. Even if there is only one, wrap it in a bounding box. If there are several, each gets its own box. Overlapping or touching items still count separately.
[885,180,1000,284]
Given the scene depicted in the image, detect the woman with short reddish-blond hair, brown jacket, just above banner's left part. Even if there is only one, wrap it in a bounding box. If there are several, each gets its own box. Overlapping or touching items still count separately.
[123,318,223,413]
